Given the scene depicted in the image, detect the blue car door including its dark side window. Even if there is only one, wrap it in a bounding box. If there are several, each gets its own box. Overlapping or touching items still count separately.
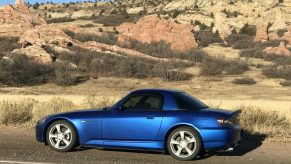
[102,94,163,144]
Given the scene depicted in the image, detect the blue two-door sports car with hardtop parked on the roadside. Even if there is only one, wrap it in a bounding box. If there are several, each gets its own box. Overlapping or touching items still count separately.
[36,89,241,160]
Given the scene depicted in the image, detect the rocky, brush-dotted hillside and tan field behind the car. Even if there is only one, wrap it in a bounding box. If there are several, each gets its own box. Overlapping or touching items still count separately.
[0,0,291,107]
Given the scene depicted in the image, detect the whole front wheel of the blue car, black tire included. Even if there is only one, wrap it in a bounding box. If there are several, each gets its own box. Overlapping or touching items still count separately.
[46,120,77,152]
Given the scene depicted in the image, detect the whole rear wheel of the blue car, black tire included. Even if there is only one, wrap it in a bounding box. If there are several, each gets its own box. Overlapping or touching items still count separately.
[167,127,201,160]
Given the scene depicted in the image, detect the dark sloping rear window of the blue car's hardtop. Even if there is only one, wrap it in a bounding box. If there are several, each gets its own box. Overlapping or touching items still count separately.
[175,92,208,110]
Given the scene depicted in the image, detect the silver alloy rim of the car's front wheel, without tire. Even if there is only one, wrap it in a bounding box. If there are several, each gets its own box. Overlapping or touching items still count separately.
[49,124,72,149]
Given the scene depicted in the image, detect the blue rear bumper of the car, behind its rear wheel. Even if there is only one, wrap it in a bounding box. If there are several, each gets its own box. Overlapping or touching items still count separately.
[202,125,243,150]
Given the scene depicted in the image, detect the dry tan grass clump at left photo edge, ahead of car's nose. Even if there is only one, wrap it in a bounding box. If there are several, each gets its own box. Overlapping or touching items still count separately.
[0,99,34,125]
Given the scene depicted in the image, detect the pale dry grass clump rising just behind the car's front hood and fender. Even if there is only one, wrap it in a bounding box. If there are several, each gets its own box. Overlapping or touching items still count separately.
[32,97,77,123]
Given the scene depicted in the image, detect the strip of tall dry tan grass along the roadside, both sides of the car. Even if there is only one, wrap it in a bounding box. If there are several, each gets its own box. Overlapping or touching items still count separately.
[0,95,291,142]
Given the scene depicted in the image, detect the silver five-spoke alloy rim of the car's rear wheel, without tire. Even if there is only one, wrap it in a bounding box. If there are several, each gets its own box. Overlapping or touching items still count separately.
[170,131,196,158]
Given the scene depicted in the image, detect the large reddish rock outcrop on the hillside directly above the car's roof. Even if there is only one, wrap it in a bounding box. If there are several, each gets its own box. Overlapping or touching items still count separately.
[116,15,198,51]
